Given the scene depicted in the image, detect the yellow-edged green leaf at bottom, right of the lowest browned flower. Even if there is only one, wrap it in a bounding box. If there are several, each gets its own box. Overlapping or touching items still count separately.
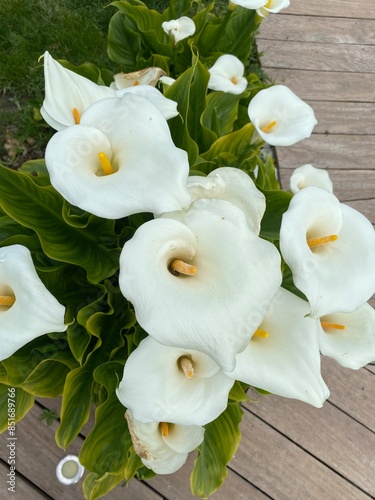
[190,404,243,498]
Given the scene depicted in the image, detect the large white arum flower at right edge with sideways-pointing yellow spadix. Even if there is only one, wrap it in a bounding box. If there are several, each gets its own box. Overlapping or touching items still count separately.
[280,186,375,317]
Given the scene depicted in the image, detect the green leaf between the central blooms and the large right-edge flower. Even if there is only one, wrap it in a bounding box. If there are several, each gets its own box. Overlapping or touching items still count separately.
[260,190,292,240]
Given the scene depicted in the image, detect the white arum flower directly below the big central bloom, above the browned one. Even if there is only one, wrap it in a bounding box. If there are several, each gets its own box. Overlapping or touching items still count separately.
[116,337,234,425]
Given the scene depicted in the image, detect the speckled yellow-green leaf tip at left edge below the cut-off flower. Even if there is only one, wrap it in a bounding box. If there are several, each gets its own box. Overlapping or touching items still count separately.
[0,384,34,437]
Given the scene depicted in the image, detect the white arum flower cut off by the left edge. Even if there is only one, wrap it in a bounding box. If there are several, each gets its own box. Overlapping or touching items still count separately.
[0,245,66,360]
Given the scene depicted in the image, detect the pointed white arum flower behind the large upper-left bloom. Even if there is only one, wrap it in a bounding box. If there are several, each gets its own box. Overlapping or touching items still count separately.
[40,52,115,130]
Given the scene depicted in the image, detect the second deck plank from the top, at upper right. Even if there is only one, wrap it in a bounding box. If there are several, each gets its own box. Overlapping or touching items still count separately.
[257,15,375,45]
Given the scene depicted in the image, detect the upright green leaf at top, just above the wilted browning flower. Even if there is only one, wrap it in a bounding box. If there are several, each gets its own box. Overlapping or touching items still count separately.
[107,12,141,73]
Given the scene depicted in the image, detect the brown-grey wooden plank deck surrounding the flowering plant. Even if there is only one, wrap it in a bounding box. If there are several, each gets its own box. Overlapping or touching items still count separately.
[0,0,375,500]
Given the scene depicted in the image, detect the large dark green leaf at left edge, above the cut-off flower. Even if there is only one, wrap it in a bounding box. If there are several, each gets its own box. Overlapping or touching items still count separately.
[0,167,120,283]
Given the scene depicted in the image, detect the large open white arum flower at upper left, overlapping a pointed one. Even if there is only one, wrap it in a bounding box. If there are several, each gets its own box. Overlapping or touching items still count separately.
[45,93,190,219]
